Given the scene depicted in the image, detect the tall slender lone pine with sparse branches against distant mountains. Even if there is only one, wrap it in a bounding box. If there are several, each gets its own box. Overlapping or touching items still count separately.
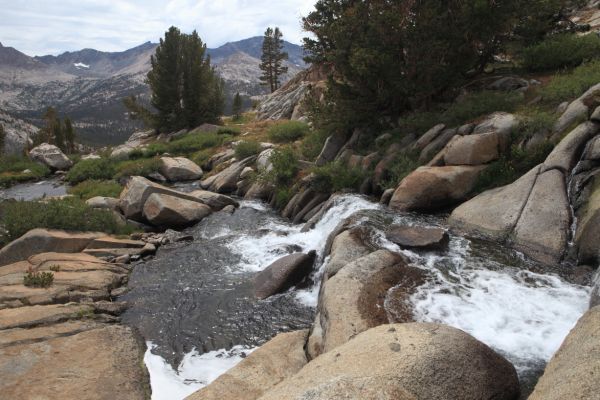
[259,28,288,92]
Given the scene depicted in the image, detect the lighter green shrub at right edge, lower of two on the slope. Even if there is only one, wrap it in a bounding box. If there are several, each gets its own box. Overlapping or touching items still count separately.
[540,60,600,103]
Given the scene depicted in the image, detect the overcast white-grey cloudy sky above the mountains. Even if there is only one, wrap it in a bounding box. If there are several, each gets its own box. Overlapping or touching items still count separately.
[0,0,316,56]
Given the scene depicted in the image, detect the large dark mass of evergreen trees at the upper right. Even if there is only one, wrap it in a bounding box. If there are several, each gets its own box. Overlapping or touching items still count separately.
[303,0,566,135]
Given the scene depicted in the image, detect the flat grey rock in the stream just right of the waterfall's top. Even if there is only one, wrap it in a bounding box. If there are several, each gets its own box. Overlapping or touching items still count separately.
[386,225,450,250]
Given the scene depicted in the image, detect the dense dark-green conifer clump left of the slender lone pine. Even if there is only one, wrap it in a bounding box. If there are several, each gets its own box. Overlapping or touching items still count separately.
[142,27,225,132]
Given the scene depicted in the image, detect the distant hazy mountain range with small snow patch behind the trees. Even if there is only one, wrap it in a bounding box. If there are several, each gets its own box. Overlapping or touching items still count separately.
[0,37,305,145]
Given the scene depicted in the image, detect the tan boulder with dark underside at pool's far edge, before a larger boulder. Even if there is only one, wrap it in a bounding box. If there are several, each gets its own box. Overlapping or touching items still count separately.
[143,193,212,228]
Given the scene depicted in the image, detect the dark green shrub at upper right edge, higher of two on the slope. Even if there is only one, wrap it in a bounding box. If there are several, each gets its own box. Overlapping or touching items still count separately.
[521,34,600,71]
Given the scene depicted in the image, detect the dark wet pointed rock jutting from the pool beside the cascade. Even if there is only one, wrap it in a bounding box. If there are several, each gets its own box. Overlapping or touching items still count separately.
[254,251,317,299]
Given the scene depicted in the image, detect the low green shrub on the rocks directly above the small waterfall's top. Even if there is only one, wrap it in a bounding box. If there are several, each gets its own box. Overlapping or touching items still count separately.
[311,161,365,193]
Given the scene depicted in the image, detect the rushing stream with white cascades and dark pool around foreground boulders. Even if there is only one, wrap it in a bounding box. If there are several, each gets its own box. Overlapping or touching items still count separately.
[122,195,590,400]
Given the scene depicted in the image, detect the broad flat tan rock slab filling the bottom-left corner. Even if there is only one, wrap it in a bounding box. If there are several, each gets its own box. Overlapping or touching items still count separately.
[0,325,149,400]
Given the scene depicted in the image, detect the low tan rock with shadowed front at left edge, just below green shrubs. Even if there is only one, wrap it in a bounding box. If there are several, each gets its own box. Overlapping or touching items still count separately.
[0,229,106,266]
